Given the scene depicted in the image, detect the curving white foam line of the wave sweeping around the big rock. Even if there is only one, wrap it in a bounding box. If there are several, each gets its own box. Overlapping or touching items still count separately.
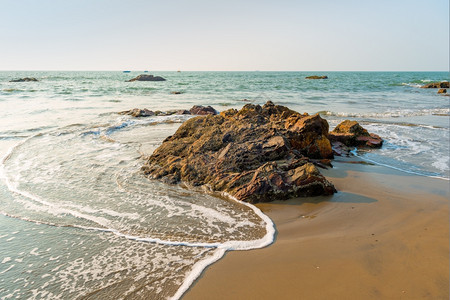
[0,131,275,299]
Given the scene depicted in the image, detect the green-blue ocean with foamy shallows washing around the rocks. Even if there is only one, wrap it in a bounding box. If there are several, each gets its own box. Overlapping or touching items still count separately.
[0,71,450,299]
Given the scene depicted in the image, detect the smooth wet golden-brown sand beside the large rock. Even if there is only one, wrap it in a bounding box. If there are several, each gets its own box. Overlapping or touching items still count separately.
[182,159,450,300]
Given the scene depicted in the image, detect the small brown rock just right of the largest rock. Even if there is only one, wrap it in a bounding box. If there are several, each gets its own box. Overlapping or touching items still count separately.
[328,120,383,150]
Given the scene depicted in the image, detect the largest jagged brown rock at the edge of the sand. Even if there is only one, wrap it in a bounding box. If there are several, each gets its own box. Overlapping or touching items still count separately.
[142,101,336,203]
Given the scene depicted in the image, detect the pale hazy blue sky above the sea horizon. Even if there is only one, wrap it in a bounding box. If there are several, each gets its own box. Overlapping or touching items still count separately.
[0,0,449,71]
